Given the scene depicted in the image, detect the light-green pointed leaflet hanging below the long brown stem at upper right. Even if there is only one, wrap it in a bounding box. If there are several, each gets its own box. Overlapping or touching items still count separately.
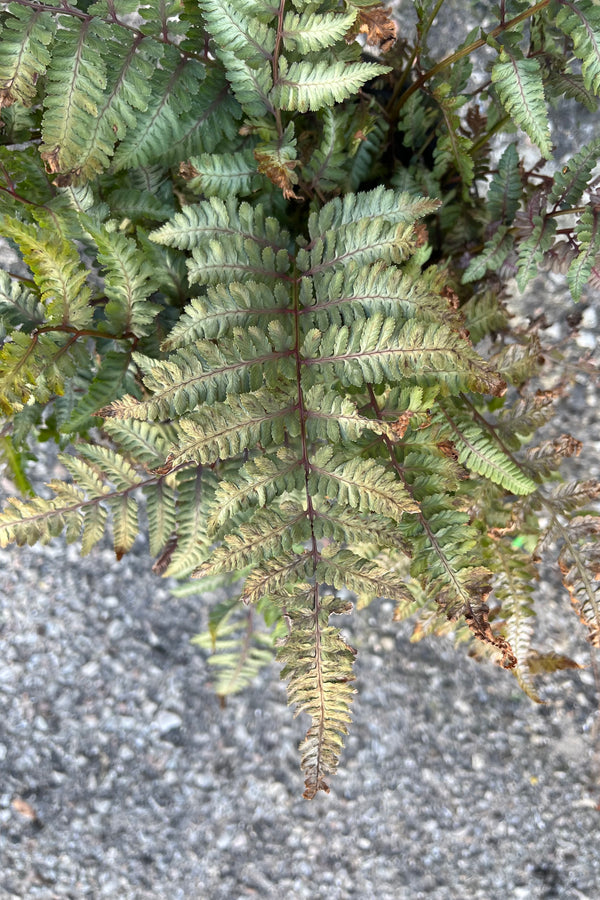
[492,49,552,159]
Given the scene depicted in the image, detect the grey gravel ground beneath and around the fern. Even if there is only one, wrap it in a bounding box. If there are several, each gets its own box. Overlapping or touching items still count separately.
[0,279,600,900]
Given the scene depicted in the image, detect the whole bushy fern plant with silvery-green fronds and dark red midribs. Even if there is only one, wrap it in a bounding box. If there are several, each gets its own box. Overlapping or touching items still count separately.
[0,0,600,798]
